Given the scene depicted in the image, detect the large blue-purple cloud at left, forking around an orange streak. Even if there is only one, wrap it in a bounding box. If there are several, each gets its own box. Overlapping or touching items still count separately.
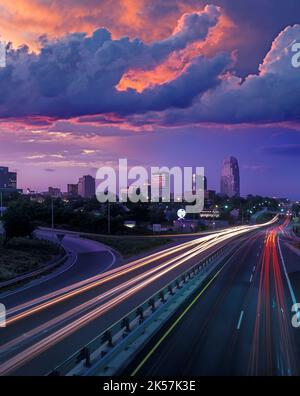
[0,6,230,119]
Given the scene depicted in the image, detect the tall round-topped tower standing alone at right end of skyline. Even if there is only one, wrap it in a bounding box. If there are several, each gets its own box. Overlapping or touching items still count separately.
[221,157,240,197]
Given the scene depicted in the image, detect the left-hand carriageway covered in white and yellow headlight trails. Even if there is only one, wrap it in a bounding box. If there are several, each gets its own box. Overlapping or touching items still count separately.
[0,221,278,375]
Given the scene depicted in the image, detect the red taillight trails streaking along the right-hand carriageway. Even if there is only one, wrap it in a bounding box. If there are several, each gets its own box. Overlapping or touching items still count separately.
[249,219,297,375]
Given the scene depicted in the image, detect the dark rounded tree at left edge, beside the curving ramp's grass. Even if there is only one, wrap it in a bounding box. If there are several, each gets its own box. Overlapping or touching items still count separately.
[3,206,35,244]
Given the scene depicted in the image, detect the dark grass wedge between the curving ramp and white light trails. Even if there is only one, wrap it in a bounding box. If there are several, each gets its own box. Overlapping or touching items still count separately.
[84,236,171,258]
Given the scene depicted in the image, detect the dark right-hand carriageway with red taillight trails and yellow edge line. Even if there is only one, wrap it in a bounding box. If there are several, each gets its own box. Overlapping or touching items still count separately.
[126,223,300,376]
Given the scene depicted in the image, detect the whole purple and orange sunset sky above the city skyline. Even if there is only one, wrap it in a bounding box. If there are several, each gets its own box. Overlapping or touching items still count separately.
[0,0,300,199]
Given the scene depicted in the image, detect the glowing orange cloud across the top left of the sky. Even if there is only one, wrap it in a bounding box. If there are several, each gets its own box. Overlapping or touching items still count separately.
[0,0,190,49]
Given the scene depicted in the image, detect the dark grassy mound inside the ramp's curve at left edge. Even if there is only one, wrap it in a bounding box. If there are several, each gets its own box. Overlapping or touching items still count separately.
[0,238,59,281]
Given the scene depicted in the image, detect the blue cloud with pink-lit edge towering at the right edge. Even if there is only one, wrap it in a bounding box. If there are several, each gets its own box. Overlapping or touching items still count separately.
[135,25,300,125]
